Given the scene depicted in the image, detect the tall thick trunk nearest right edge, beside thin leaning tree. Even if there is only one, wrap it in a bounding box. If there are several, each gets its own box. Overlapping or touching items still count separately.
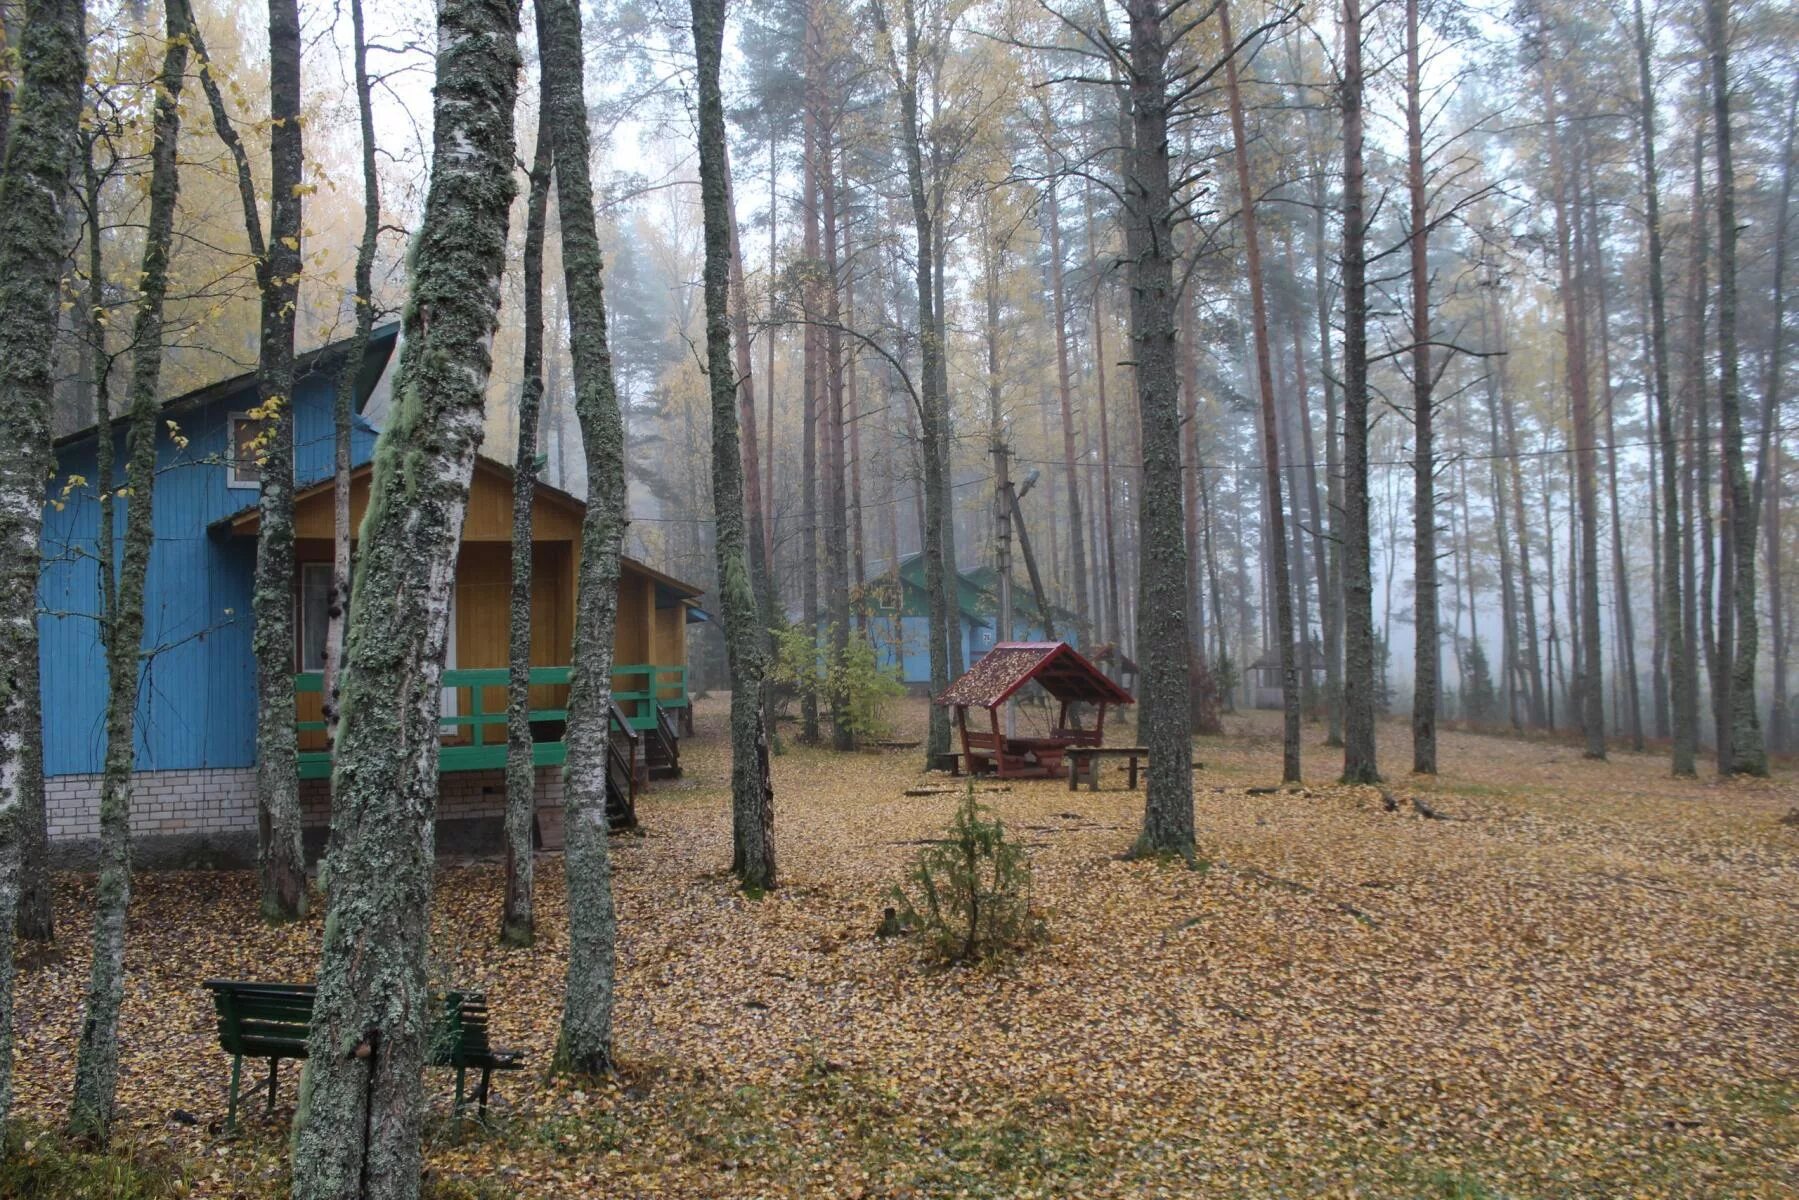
[1705,0,1768,775]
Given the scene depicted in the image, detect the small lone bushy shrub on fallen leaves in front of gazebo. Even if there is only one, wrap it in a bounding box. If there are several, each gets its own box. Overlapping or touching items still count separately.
[892,783,1043,963]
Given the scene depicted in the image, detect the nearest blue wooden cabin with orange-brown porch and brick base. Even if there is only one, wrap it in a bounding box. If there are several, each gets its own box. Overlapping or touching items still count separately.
[38,326,703,862]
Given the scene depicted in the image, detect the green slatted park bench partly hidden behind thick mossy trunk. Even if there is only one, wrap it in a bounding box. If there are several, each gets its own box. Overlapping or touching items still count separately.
[205,979,525,1130]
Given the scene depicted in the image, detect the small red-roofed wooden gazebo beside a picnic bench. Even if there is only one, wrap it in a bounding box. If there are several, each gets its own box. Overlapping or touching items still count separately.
[937,642,1135,779]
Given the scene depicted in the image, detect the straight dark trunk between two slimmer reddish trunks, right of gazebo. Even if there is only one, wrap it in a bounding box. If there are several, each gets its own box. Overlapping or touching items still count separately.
[1342,0,1380,783]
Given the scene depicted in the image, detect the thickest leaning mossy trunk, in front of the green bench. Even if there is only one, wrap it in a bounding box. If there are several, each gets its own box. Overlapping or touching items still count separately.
[293,0,520,1200]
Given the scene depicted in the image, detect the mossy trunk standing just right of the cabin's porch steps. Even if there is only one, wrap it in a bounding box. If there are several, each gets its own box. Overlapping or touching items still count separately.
[693,0,775,891]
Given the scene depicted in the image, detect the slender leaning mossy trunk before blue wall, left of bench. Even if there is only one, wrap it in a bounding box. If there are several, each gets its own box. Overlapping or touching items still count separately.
[68,4,187,1141]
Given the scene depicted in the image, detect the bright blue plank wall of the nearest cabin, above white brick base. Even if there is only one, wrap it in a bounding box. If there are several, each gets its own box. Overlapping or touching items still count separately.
[38,333,394,775]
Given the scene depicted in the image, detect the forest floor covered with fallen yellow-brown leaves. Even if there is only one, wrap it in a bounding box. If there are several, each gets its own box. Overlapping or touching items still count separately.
[18,703,1799,1200]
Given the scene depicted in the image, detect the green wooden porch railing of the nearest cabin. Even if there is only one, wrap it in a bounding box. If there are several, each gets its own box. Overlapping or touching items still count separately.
[293,664,691,779]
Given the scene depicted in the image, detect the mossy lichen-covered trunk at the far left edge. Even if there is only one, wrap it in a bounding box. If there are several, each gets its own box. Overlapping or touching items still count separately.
[0,0,86,1139]
